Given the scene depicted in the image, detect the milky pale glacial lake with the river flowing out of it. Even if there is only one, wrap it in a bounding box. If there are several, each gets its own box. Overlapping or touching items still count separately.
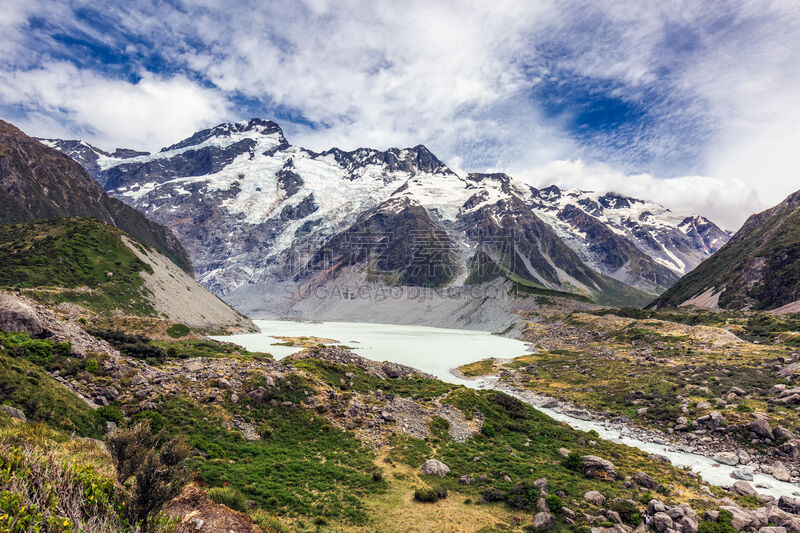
[216,320,800,496]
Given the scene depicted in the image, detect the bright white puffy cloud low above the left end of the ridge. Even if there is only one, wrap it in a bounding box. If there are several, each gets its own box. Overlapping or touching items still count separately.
[0,62,229,150]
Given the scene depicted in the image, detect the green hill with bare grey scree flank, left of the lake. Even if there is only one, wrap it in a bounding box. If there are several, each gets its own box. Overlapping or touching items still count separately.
[0,218,252,330]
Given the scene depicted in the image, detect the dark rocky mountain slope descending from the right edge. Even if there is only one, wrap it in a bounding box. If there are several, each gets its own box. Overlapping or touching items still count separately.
[652,191,800,312]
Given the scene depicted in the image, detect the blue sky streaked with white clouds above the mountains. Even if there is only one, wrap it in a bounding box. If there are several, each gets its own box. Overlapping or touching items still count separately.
[0,0,800,229]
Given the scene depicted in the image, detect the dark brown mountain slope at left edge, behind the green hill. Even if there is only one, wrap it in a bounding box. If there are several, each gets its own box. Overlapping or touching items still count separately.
[0,120,191,272]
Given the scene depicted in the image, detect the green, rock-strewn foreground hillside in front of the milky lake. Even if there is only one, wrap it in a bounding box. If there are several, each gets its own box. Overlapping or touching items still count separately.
[0,330,772,533]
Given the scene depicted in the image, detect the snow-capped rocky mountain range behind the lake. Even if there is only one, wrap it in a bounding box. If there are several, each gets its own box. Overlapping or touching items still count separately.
[43,119,728,314]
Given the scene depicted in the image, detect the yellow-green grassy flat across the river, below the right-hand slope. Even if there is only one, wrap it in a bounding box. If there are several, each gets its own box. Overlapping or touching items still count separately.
[461,310,797,445]
